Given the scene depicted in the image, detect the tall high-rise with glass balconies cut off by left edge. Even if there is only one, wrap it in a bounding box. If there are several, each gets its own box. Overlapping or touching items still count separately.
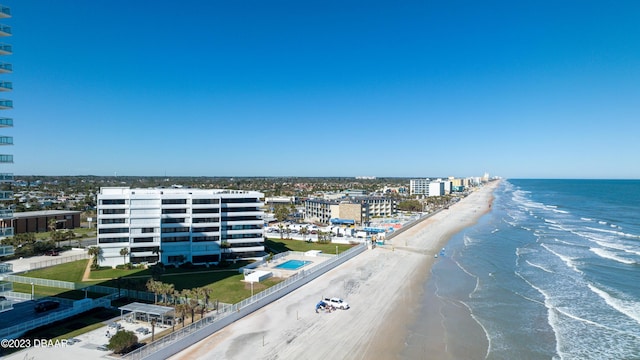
[0,5,13,238]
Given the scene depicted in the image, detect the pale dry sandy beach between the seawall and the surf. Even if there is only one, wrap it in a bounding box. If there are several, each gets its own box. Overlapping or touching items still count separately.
[172,182,498,359]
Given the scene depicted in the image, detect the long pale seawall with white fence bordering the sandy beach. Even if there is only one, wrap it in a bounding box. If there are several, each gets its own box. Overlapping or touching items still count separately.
[124,244,367,360]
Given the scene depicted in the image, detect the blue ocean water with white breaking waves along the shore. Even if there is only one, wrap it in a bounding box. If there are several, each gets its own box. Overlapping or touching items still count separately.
[402,180,640,359]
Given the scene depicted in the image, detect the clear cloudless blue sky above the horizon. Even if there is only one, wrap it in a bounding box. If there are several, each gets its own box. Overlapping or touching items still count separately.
[5,0,640,178]
